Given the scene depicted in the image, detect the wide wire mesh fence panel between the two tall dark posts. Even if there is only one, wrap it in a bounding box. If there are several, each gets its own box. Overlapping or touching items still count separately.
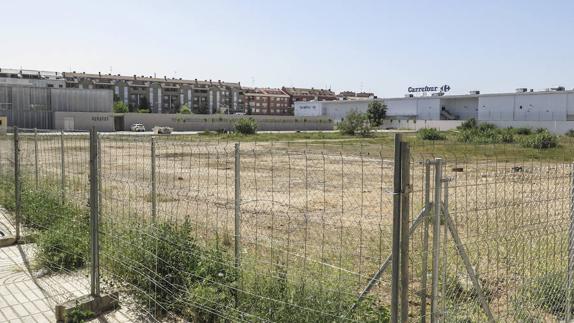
[100,135,398,321]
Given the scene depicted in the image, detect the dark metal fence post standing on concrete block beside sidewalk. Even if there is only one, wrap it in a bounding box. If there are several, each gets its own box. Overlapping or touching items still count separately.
[90,127,100,296]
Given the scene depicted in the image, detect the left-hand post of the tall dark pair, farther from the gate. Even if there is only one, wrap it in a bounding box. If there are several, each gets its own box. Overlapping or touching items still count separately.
[391,134,402,323]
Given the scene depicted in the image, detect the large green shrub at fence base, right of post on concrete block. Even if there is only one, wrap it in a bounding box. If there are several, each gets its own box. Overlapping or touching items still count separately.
[102,222,238,322]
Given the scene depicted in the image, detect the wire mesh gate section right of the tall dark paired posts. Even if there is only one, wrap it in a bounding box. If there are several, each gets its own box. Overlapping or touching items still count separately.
[408,156,574,322]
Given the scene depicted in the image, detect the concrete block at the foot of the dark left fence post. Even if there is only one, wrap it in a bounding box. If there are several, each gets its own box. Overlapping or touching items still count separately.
[56,292,119,322]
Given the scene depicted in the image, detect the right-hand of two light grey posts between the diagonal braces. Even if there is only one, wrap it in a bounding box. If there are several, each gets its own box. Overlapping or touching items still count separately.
[431,158,442,322]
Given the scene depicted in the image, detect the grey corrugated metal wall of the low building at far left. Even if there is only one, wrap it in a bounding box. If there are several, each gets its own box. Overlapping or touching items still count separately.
[0,85,113,129]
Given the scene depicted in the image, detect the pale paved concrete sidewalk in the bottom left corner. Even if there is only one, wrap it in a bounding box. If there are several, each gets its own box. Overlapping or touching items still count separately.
[0,211,139,322]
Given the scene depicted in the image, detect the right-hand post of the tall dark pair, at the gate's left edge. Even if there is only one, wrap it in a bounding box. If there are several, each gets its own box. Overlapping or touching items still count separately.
[400,142,411,322]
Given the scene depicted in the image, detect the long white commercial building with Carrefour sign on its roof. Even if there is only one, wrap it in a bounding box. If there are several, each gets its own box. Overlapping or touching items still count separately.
[295,87,574,133]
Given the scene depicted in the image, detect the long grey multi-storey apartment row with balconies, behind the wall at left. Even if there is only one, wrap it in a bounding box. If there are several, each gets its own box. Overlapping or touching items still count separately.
[62,72,243,114]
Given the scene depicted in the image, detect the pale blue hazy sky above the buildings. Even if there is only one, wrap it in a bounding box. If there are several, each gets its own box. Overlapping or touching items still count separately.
[4,0,574,96]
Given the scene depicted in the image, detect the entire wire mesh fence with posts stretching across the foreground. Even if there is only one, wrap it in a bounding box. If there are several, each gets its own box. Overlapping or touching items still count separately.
[0,129,573,322]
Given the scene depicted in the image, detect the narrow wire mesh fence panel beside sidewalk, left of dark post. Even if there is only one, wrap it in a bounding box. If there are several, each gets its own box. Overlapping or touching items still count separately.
[0,129,94,310]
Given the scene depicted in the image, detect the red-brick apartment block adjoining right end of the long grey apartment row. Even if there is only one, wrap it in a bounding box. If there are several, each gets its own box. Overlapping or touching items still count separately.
[243,88,291,115]
